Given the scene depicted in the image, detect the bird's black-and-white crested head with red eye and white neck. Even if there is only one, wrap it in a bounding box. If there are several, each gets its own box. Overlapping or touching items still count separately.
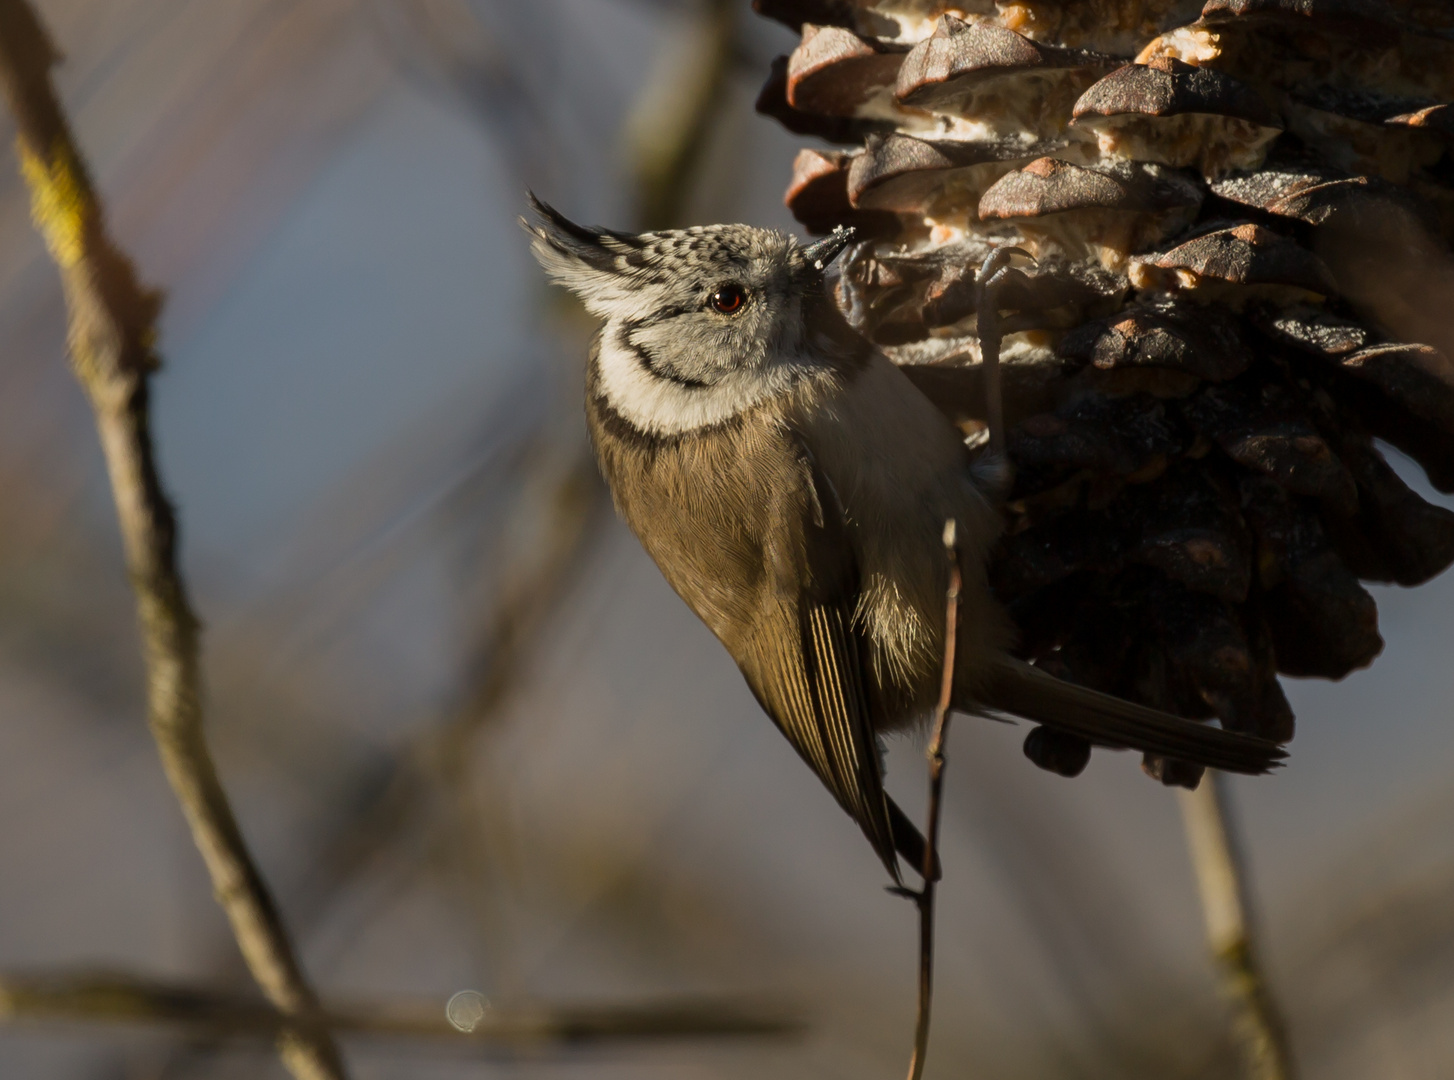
[523,195,862,435]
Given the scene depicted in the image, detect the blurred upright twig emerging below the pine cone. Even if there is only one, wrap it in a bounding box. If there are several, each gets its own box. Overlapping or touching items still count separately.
[1181,769,1297,1080]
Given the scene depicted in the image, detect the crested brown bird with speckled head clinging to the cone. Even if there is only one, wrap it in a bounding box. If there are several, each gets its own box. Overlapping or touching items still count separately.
[521,195,1282,882]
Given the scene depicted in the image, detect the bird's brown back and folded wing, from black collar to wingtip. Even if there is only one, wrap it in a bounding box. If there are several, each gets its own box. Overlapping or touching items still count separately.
[586,383,923,881]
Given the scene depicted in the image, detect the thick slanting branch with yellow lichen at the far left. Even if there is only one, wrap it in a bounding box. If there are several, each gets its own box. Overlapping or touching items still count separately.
[0,0,345,1080]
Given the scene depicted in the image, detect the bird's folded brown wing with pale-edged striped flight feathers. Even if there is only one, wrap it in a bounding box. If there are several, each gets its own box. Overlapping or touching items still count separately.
[743,444,913,881]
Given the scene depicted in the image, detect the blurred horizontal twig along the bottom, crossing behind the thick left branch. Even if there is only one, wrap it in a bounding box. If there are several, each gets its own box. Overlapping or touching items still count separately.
[0,972,803,1049]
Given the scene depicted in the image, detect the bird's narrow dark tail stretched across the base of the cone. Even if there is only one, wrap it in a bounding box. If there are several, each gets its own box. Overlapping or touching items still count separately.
[977,657,1287,775]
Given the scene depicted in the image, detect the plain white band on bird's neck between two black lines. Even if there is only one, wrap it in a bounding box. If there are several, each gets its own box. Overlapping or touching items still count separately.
[596,326,795,435]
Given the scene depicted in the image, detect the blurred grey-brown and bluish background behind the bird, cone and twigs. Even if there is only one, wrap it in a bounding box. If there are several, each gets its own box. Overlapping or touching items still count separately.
[0,0,1454,1080]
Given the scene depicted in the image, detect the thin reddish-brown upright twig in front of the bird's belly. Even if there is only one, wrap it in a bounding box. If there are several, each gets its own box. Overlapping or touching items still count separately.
[907,517,963,1080]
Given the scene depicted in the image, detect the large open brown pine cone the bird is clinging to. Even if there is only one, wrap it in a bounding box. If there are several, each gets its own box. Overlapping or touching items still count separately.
[755,0,1454,785]
